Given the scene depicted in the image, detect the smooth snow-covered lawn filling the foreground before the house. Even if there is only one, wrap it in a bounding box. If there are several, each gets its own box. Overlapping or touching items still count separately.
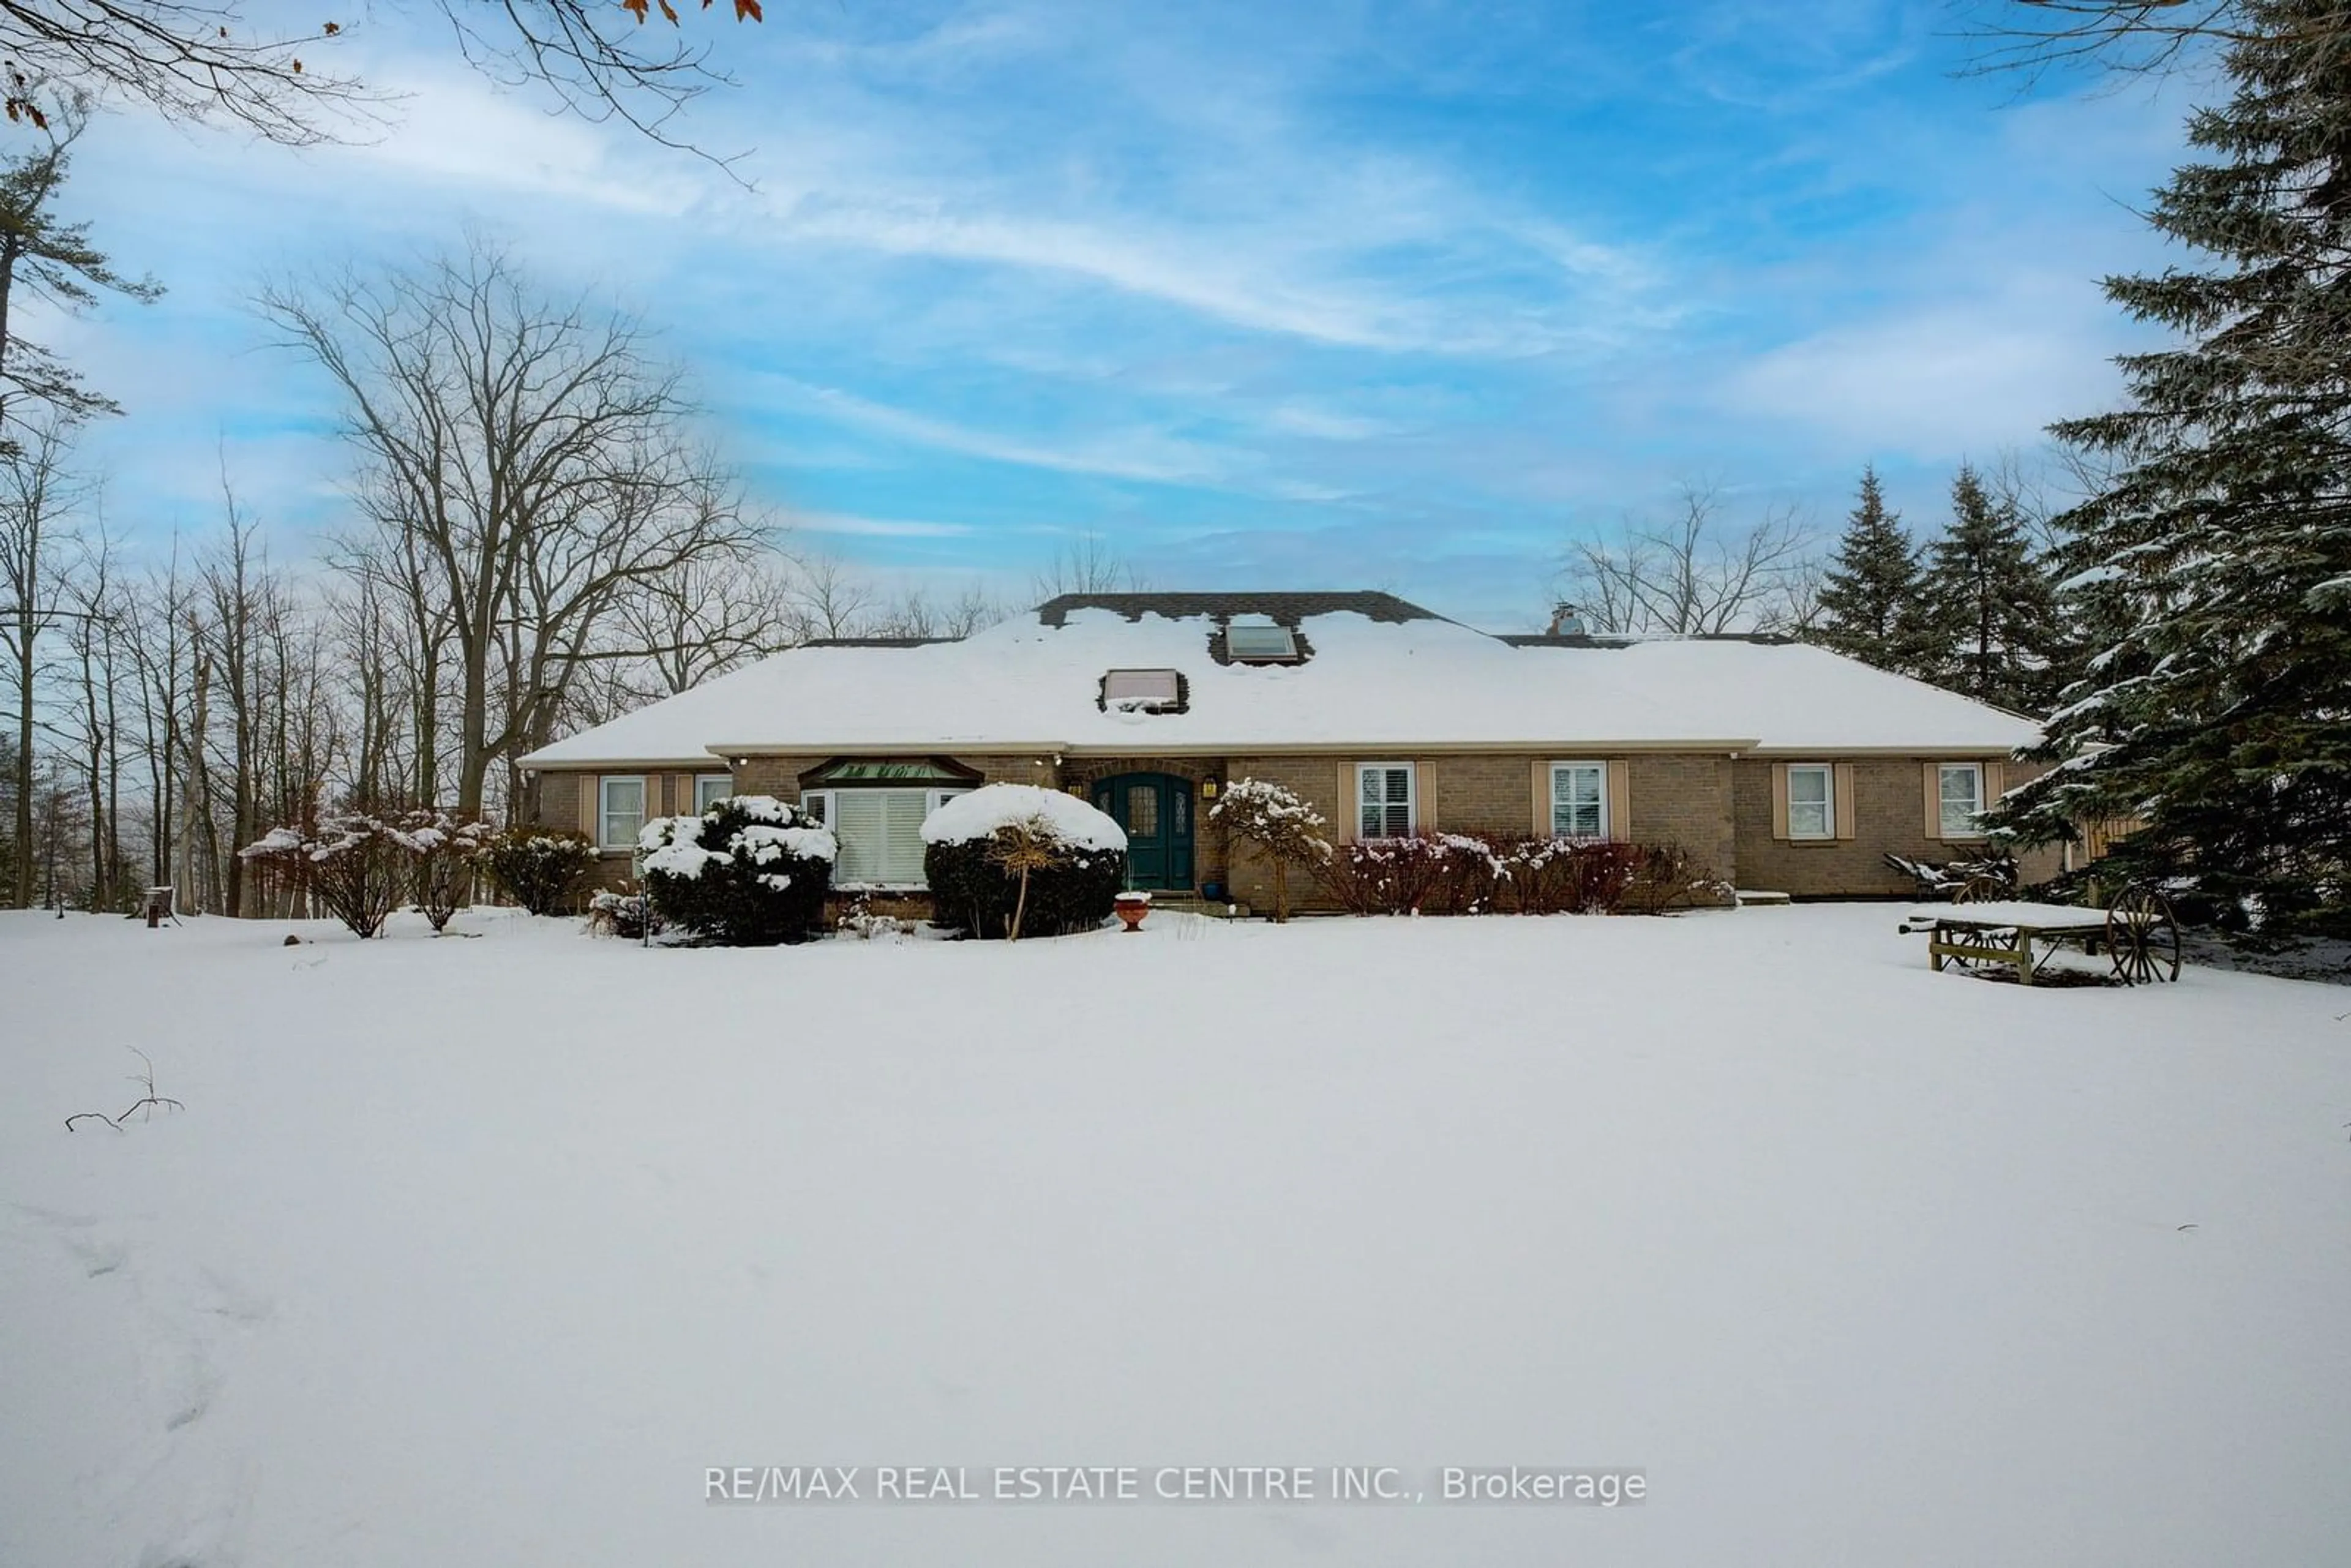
[0,905,2351,1568]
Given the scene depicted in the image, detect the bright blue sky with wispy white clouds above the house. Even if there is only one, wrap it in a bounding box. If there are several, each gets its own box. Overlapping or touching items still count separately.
[50,0,2184,628]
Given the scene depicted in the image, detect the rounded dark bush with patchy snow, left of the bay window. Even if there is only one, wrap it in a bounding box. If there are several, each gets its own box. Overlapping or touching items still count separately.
[637,795,839,947]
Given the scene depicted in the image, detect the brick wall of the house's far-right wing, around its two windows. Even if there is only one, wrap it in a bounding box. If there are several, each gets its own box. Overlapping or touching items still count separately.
[1733,757,2057,898]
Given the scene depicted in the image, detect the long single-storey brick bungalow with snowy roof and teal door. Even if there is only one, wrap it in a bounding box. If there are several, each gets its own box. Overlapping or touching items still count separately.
[522,593,2038,905]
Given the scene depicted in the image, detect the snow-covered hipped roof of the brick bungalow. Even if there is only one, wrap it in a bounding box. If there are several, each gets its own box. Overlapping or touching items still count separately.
[522,595,2038,769]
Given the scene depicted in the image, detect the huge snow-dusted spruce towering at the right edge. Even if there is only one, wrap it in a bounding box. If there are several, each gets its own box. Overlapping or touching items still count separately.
[2001,0,2351,917]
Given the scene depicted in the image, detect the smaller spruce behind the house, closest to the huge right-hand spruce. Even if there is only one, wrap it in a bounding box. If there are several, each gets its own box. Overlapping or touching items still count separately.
[1916,463,2057,712]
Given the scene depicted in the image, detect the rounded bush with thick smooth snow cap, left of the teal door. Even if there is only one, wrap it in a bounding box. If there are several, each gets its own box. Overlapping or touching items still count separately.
[921,785,1126,938]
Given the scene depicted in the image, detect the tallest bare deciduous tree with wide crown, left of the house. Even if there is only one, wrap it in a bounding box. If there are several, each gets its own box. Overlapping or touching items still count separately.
[261,242,759,818]
